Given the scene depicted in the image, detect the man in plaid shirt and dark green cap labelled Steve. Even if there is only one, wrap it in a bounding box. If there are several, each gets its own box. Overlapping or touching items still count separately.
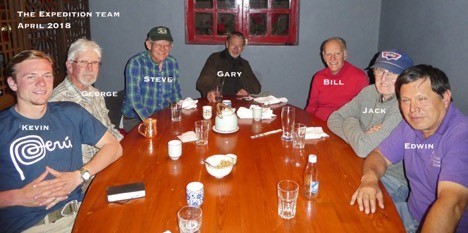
[122,26,181,132]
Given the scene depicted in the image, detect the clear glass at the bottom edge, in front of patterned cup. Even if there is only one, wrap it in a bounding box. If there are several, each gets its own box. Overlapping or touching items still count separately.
[177,206,202,233]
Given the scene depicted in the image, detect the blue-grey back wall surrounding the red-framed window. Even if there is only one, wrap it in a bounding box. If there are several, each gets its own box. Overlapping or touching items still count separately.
[90,0,381,107]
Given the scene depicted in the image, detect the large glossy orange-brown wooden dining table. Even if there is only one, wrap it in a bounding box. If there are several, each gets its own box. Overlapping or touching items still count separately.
[74,98,404,232]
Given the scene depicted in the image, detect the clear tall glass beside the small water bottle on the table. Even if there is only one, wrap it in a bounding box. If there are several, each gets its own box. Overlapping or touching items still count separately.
[278,180,299,219]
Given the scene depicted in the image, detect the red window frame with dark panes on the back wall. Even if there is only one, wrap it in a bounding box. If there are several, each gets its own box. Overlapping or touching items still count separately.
[185,0,299,45]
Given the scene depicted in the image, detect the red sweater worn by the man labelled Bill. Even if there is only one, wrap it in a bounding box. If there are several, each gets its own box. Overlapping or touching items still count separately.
[306,61,369,121]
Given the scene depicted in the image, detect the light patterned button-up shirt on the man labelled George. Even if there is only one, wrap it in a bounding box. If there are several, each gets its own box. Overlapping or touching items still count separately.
[49,76,123,164]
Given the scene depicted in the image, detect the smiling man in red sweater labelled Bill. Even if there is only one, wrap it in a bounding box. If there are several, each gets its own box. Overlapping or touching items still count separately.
[306,37,369,121]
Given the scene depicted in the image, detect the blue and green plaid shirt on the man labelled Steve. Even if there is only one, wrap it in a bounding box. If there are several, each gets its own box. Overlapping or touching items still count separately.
[122,51,181,119]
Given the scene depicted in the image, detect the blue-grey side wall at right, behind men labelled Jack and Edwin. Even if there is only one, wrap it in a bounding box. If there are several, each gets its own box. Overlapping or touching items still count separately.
[379,0,468,114]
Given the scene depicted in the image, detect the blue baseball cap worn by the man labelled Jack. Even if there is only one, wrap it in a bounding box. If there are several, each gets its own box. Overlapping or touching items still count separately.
[371,49,413,75]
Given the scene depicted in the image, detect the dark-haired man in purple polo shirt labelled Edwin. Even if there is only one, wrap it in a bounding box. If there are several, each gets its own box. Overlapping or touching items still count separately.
[351,65,468,232]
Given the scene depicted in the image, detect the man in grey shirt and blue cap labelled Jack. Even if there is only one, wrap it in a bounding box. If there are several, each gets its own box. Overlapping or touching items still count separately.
[327,50,413,202]
